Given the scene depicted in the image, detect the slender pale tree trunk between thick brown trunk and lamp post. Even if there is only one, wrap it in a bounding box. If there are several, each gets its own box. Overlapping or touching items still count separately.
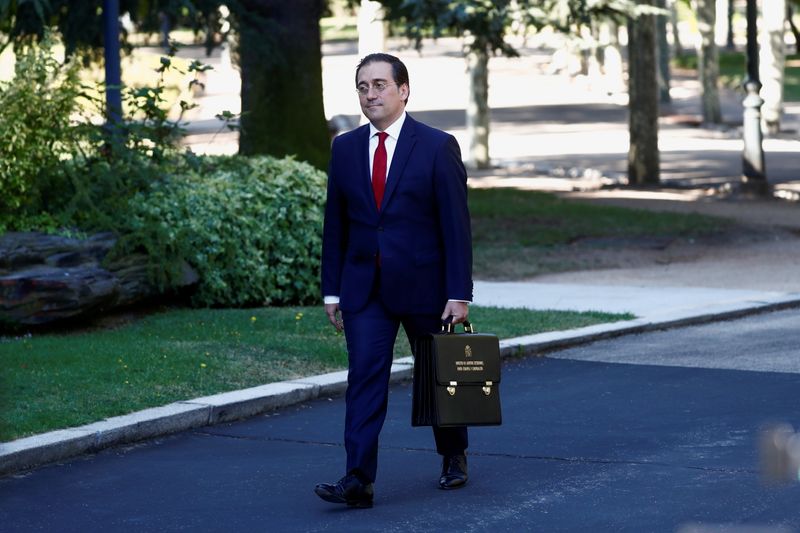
[692,0,722,124]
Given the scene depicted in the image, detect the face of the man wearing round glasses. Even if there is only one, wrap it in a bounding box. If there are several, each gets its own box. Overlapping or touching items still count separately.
[356,61,409,131]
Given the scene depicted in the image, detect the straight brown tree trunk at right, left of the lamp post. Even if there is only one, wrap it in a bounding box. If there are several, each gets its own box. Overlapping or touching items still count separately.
[628,15,660,185]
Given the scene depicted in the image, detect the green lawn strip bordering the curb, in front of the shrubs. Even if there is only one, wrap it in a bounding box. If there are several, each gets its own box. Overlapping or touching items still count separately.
[0,306,632,442]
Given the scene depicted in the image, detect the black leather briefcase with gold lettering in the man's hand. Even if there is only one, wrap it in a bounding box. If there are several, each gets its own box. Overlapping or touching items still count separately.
[411,322,502,427]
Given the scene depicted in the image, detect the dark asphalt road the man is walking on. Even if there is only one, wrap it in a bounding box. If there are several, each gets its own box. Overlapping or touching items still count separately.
[0,310,800,532]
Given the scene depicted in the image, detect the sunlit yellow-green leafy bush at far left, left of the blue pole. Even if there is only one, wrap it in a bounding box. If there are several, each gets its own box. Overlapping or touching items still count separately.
[0,36,81,232]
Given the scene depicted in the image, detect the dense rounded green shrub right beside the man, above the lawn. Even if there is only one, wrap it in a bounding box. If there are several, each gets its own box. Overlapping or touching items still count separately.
[122,156,325,306]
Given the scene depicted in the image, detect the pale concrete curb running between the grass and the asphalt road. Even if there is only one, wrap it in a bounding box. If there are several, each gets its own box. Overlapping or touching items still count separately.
[0,293,800,476]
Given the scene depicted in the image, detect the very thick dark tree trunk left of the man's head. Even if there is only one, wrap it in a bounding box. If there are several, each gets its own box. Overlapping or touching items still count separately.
[232,0,330,168]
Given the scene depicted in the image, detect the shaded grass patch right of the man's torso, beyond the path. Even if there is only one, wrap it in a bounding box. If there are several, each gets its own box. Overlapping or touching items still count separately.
[469,188,731,280]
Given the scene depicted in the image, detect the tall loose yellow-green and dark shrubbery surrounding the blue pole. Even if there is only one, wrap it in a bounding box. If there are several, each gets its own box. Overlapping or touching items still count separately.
[0,34,216,233]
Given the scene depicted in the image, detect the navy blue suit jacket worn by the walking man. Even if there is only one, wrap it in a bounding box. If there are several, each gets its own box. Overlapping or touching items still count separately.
[322,115,472,314]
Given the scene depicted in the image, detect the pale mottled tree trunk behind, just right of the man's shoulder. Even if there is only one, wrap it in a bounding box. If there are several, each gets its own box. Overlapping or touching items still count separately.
[466,49,490,168]
